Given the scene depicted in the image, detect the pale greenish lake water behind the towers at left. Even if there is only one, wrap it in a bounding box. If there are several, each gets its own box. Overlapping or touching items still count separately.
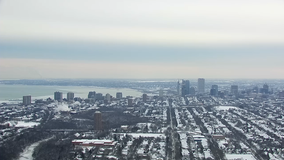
[0,84,143,101]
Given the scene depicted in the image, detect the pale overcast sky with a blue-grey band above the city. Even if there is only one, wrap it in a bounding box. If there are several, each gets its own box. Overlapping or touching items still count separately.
[0,0,284,79]
